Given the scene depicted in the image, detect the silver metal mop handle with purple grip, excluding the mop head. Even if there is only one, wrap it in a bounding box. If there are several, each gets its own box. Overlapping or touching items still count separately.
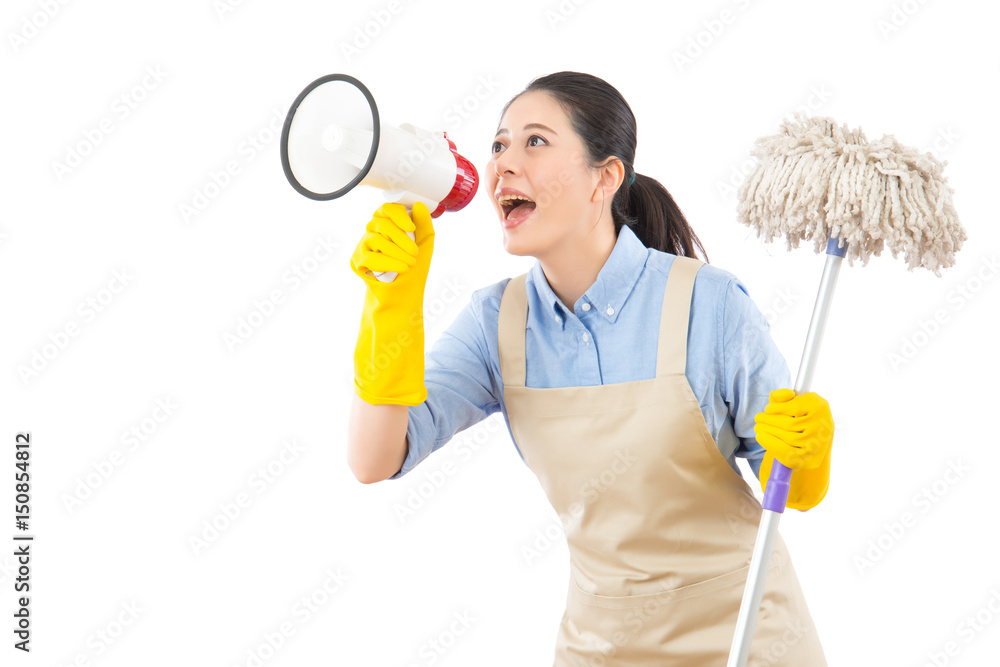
[727,237,847,667]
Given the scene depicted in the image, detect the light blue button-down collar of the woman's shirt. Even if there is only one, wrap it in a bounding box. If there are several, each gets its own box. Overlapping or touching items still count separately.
[527,225,649,326]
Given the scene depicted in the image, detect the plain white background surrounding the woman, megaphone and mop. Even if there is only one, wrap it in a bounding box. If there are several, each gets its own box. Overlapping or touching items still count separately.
[0,0,1000,667]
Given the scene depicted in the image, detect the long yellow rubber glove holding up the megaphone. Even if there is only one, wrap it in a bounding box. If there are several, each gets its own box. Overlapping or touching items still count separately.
[351,202,434,405]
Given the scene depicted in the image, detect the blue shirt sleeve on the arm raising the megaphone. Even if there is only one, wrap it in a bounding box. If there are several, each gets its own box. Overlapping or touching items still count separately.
[389,290,500,479]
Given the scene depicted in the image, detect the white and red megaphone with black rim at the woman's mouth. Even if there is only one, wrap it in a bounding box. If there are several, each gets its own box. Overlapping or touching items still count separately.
[281,74,479,282]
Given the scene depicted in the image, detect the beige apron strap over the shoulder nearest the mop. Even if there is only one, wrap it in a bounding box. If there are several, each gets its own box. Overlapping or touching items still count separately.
[656,255,705,377]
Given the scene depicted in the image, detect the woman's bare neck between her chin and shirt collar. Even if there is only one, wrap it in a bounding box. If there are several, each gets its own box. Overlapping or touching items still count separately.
[536,220,618,310]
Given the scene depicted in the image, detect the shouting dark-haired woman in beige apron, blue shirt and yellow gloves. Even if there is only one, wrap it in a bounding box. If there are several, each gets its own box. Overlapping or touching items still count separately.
[349,72,833,667]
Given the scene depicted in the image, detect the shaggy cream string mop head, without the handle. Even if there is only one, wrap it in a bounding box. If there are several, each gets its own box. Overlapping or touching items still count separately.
[737,114,966,277]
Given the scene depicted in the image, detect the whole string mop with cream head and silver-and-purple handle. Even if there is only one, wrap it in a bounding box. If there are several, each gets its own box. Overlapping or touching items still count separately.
[728,114,966,667]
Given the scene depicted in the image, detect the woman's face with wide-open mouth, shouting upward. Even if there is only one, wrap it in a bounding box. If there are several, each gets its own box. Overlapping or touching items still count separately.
[486,91,610,256]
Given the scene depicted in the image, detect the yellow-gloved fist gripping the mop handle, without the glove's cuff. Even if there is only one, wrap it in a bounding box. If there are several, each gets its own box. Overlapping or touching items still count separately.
[753,389,833,470]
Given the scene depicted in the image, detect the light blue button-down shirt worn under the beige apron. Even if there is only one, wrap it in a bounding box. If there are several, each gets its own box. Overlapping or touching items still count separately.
[389,227,792,479]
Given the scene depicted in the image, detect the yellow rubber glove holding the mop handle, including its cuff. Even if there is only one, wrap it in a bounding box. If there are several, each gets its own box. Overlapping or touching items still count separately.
[754,389,834,511]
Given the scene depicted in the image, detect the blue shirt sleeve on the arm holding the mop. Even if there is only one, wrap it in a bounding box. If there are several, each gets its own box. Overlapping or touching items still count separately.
[722,278,792,477]
